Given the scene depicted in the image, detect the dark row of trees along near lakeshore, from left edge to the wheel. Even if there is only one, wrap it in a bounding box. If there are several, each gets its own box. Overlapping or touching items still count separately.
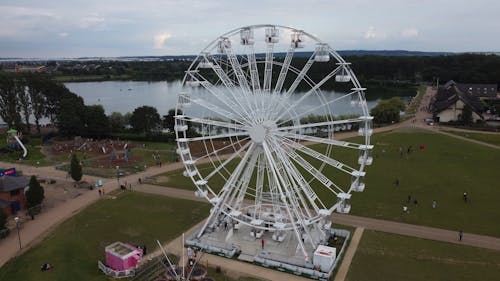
[0,72,186,138]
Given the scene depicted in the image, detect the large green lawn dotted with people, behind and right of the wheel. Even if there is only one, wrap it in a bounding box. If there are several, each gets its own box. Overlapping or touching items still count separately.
[151,129,500,237]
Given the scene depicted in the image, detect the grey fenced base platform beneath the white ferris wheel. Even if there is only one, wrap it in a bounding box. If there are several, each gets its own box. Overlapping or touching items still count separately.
[186,225,350,280]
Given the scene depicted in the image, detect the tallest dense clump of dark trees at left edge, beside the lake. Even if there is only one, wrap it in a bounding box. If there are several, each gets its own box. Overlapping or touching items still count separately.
[0,72,108,136]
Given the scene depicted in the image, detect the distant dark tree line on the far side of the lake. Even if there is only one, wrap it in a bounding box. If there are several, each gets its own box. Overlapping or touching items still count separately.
[23,54,500,88]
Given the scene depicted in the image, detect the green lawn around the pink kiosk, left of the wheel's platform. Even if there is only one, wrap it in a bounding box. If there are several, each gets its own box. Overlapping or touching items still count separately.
[0,192,208,281]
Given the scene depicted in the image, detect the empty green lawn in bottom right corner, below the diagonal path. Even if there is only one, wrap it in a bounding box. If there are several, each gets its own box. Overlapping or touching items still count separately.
[346,230,500,281]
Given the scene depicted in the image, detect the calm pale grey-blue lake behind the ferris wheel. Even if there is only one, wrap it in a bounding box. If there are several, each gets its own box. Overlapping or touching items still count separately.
[64,81,378,115]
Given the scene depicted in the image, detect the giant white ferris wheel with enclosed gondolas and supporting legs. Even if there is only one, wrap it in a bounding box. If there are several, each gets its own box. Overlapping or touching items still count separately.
[174,25,373,259]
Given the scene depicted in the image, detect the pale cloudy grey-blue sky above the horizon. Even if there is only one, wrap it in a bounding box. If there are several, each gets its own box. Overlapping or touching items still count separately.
[0,0,500,58]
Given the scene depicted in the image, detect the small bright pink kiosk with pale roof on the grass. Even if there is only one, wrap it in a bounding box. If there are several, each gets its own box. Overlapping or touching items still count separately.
[106,242,142,271]
